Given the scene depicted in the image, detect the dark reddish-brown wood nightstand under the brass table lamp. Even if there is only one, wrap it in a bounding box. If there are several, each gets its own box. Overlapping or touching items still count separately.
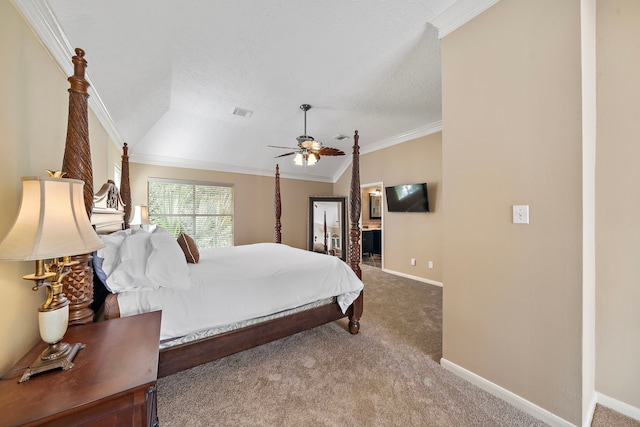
[0,311,161,426]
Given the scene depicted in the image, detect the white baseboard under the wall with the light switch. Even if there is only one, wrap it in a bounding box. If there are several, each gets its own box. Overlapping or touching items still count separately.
[440,358,576,427]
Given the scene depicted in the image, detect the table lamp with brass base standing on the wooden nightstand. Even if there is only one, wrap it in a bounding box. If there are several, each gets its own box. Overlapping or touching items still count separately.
[0,174,104,382]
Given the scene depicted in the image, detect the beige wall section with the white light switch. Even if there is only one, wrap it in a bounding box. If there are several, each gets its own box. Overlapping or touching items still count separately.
[442,0,582,424]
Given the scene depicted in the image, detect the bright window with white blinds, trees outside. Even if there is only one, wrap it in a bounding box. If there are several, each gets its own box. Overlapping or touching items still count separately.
[149,178,233,248]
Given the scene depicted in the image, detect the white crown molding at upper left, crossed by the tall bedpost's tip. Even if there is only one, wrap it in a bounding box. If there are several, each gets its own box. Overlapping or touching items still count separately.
[11,0,124,145]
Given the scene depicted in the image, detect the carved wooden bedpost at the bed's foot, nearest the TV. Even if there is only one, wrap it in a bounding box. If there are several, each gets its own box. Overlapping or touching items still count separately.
[349,130,364,334]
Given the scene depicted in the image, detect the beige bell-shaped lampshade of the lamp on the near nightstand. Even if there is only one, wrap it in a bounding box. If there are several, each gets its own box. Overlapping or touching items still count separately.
[0,177,104,261]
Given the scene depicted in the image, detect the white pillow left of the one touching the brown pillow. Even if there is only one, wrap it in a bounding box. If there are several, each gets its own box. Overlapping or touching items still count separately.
[105,231,160,293]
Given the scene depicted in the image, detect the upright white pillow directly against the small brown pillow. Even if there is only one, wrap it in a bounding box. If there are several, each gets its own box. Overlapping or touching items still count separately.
[146,227,191,290]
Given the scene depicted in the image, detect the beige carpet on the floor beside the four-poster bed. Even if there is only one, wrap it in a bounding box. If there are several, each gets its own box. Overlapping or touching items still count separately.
[158,265,636,427]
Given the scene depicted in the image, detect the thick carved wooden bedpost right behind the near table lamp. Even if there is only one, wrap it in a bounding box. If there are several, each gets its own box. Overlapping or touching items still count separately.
[62,48,93,325]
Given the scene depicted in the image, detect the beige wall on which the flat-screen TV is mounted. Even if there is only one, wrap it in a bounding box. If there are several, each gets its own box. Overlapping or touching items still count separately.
[334,132,443,283]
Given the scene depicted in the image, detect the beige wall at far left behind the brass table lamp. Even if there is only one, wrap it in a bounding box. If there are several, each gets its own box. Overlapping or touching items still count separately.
[0,1,113,374]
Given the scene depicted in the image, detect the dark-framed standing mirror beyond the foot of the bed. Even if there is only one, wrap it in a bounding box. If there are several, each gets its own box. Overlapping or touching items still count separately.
[308,197,347,261]
